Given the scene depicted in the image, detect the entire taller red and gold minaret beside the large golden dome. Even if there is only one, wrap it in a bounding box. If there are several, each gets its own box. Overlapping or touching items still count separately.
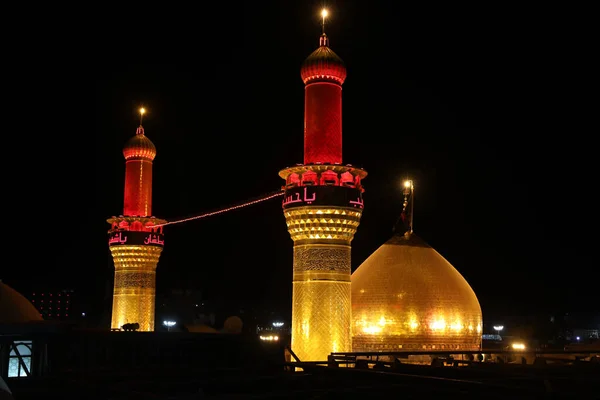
[279,10,367,361]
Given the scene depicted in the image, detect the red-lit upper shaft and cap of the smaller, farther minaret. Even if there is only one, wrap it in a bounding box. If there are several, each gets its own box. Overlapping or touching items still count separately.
[123,125,156,217]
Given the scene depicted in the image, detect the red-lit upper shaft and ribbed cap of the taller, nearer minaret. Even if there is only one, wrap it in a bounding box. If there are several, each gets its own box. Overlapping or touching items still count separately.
[300,34,346,164]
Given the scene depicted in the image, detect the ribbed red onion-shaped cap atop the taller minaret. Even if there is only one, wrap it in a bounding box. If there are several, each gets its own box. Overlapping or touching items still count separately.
[300,34,346,85]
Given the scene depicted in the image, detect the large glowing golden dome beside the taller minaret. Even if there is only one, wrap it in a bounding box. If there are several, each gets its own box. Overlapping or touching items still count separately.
[352,233,482,351]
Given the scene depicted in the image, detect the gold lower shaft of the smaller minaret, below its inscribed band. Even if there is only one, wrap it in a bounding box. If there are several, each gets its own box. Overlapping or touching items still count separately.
[110,245,162,332]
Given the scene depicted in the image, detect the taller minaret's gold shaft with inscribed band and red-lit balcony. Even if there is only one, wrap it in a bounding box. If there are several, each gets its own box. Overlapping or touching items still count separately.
[279,164,367,361]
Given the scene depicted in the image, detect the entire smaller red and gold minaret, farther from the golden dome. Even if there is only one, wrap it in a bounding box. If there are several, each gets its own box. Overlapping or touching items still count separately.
[107,108,166,332]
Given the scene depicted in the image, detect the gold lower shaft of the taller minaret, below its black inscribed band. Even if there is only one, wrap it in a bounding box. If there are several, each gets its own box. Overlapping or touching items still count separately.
[284,206,362,361]
